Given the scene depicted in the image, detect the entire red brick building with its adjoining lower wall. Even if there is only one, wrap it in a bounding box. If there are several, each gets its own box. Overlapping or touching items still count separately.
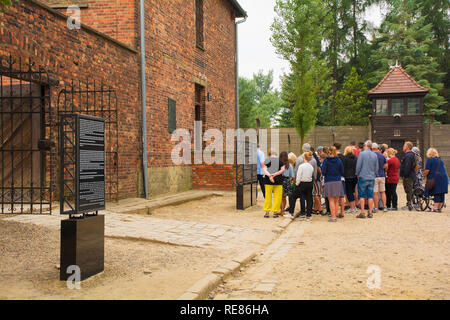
[0,0,246,206]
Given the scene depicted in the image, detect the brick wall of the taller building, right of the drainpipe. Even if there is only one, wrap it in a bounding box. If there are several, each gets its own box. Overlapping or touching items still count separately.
[146,0,235,194]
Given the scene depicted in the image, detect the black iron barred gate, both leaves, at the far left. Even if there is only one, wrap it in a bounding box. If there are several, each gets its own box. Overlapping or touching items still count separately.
[0,56,119,214]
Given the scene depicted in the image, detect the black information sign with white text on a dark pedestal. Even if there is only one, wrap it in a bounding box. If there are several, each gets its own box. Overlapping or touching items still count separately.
[59,114,105,280]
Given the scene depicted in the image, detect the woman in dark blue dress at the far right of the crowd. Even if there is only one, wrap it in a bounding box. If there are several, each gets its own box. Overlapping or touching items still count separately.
[423,148,449,212]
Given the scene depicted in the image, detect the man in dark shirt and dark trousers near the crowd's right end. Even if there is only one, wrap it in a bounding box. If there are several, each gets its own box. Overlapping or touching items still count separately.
[400,141,416,211]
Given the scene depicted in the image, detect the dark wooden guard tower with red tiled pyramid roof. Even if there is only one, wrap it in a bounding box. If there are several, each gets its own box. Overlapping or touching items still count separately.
[369,65,429,158]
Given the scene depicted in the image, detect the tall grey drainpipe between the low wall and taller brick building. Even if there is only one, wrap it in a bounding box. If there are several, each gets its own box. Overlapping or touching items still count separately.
[139,0,148,199]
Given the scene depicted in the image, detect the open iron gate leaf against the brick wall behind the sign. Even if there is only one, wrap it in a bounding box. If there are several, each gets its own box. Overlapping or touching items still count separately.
[55,81,119,204]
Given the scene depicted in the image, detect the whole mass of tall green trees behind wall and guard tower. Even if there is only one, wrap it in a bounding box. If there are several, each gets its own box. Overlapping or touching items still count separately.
[272,0,450,129]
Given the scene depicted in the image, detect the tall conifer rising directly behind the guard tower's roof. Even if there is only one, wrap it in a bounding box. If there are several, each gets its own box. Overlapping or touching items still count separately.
[374,0,445,119]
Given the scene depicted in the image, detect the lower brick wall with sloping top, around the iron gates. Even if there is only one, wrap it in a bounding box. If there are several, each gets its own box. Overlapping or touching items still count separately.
[0,0,141,197]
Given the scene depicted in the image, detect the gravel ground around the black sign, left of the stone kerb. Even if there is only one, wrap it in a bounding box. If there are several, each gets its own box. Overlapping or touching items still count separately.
[0,219,232,299]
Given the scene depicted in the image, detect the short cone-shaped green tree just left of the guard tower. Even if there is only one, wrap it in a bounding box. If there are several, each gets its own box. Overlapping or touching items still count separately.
[336,68,371,126]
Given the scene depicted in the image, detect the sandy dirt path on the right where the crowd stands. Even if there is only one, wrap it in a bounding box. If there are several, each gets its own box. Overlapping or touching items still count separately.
[215,208,450,299]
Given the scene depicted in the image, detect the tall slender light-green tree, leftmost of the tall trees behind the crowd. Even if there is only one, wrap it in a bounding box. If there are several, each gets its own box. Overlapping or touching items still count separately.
[271,0,324,144]
